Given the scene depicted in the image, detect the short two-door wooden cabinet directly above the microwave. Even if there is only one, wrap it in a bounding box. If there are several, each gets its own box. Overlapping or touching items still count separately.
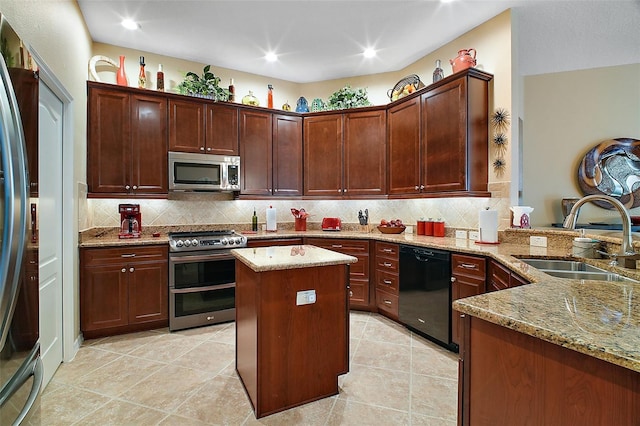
[169,96,239,155]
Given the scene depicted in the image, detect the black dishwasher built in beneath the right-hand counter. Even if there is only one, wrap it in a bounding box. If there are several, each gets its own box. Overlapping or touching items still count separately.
[398,245,452,349]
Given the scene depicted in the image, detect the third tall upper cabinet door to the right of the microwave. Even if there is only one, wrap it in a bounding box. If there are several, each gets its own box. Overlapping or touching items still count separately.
[303,114,344,197]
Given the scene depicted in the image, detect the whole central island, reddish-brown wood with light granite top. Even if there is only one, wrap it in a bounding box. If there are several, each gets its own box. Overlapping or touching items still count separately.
[231,245,357,418]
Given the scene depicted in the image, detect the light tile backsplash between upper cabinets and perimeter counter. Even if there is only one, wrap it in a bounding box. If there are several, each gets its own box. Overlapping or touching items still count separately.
[87,193,510,230]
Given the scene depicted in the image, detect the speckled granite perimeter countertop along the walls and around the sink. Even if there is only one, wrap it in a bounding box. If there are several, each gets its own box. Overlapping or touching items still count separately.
[80,227,640,372]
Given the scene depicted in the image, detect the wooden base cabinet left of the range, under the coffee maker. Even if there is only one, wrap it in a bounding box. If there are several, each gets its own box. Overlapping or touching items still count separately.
[80,246,169,338]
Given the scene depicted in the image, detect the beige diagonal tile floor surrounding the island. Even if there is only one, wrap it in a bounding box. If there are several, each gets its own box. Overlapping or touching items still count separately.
[40,311,458,426]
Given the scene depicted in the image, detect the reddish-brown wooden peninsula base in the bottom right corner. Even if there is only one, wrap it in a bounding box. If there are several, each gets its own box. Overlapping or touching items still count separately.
[458,315,640,426]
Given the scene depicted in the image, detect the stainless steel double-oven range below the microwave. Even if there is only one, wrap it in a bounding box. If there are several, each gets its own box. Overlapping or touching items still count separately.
[169,230,247,331]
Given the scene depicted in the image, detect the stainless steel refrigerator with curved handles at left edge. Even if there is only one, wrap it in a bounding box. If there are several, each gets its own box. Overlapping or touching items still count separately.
[0,19,43,425]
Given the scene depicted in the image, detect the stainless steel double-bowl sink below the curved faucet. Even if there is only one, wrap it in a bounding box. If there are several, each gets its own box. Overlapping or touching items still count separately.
[520,259,638,283]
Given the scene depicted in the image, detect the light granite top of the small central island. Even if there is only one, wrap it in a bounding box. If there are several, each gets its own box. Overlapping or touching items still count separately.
[231,245,358,272]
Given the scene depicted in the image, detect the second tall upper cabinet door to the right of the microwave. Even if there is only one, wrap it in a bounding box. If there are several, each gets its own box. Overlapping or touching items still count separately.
[272,114,302,195]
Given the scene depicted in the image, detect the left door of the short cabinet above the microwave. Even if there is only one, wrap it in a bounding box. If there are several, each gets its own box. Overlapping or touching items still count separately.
[169,98,205,153]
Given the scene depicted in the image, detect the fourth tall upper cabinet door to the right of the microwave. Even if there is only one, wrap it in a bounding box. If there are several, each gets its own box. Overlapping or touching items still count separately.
[344,110,387,196]
